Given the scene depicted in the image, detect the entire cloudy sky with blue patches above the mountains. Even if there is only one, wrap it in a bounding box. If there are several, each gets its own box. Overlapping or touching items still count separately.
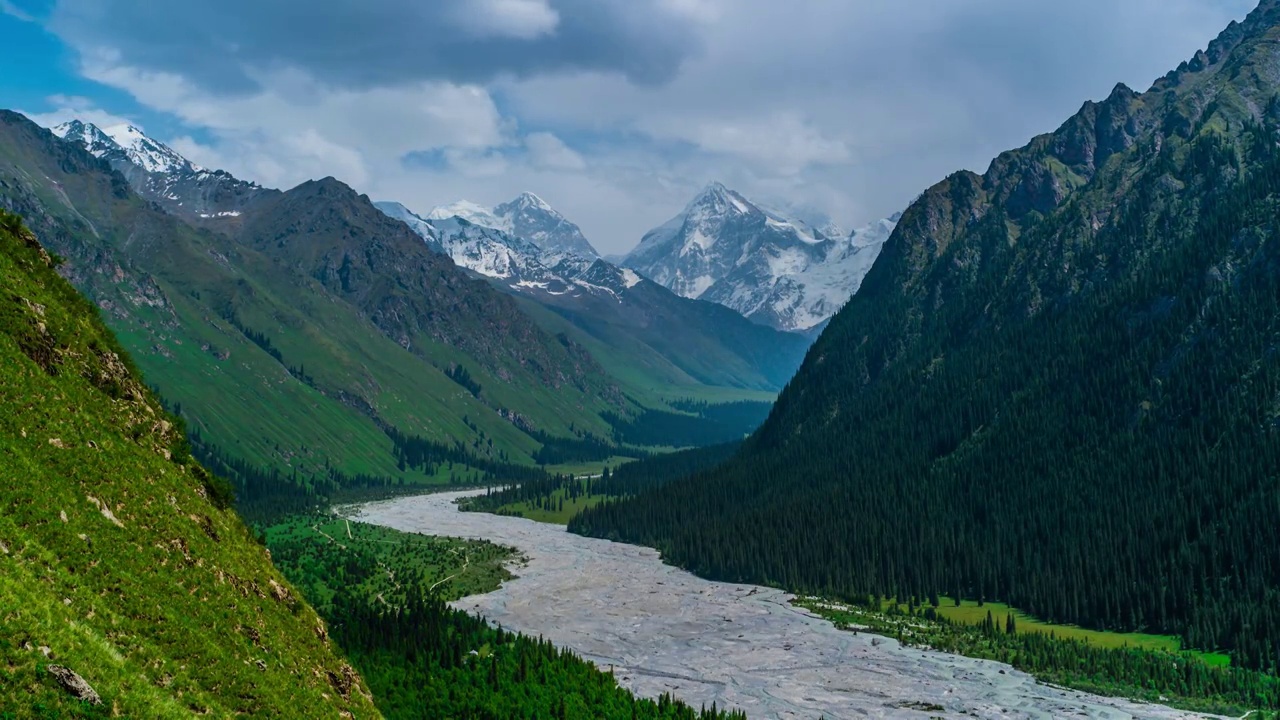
[0,0,1256,254]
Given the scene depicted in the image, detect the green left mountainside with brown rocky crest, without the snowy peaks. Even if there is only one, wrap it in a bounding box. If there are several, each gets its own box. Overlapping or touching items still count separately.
[0,107,635,509]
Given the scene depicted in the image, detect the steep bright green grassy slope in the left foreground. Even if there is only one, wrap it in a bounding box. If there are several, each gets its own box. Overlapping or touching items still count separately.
[0,213,376,717]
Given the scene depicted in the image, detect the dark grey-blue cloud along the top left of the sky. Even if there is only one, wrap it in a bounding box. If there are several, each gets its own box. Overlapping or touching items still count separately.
[50,0,699,90]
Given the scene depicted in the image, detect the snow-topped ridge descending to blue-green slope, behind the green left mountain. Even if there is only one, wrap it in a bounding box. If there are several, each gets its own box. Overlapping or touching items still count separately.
[376,202,809,397]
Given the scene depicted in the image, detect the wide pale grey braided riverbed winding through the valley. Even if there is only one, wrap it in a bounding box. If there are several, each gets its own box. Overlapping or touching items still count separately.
[349,493,1218,720]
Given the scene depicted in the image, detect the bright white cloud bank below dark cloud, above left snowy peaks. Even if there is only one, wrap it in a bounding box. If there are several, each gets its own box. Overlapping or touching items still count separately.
[73,53,513,187]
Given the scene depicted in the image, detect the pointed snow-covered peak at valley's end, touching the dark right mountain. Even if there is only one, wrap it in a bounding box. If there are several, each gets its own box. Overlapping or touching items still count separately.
[623,183,896,331]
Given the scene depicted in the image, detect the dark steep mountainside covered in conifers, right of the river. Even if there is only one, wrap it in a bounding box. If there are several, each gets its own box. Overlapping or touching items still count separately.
[571,0,1280,670]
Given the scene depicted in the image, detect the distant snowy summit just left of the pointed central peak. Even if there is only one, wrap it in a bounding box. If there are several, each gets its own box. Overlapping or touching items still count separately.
[426,192,600,260]
